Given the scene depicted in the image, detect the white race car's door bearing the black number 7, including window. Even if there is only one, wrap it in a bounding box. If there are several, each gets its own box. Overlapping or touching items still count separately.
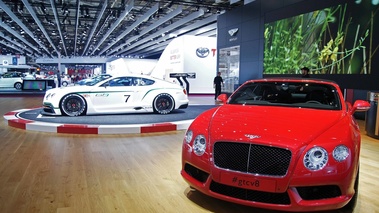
[90,77,136,113]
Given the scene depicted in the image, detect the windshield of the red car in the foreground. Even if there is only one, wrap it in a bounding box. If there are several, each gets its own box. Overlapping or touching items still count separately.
[229,82,341,110]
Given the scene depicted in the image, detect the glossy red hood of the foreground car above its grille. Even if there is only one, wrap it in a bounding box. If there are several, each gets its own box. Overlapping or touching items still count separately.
[209,105,346,148]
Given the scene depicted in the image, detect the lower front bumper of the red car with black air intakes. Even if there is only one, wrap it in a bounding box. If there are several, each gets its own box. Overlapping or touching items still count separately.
[181,163,353,212]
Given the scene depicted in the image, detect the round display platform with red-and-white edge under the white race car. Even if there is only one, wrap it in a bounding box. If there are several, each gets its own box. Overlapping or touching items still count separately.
[4,105,217,134]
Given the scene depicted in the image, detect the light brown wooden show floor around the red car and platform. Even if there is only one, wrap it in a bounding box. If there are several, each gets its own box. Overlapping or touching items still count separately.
[0,97,379,213]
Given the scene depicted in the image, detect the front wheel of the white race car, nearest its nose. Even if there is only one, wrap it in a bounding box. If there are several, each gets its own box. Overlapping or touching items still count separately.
[60,94,87,116]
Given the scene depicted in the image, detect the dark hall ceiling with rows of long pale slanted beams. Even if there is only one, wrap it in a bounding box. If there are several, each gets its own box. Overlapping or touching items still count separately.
[0,0,240,60]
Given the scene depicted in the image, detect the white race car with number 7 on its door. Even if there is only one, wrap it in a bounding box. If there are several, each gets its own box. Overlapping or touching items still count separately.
[42,76,189,116]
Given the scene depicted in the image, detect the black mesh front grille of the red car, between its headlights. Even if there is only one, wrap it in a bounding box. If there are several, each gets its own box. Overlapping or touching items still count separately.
[213,142,291,176]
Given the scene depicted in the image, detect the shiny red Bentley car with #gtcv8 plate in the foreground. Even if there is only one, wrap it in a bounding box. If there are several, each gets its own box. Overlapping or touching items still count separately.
[181,78,370,211]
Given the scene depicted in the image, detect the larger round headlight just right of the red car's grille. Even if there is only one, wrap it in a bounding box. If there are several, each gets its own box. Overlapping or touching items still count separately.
[303,147,328,171]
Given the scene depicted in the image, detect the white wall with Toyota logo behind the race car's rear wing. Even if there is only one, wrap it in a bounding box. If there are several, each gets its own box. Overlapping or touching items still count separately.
[151,35,217,94]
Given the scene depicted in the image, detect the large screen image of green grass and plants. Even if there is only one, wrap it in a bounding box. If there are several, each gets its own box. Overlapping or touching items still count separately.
[264,1,379,74]
